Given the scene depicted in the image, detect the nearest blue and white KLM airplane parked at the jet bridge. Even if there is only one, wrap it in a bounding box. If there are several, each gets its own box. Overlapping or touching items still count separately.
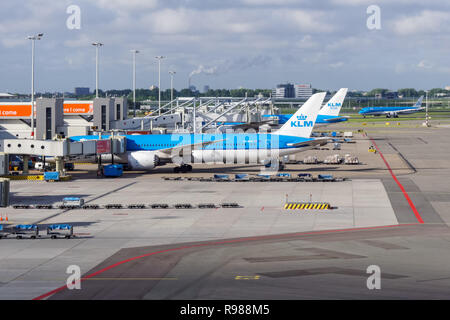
[70,92,327,172]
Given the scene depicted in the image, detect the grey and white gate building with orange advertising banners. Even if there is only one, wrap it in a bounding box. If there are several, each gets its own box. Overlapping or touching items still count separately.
[0,97,128,140]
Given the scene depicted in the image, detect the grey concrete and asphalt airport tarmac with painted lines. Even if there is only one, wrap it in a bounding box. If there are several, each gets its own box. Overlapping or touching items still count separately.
[0,119,450,299]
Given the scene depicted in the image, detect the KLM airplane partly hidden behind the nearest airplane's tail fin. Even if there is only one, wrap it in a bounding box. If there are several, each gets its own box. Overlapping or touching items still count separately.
[263,88,348,127]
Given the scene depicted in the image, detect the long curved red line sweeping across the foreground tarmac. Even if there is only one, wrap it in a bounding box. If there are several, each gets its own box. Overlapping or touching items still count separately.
[33,223,417,300]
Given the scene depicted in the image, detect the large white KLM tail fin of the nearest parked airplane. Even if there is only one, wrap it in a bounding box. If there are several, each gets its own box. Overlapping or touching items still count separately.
[274,92,327,138]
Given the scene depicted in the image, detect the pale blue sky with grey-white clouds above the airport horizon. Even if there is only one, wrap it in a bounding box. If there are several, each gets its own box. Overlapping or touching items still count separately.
[0,0,450,93]
